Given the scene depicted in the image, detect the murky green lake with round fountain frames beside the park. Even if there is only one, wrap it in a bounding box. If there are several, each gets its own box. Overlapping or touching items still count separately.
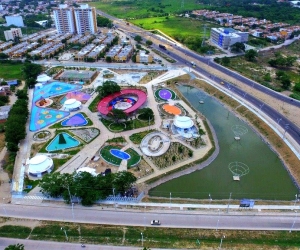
[149,86,298,200]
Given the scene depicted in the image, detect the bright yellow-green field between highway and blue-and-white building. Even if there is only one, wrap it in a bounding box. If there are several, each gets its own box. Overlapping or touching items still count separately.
[130,16,213,40]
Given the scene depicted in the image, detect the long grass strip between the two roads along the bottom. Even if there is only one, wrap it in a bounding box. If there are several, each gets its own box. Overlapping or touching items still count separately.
[0,223,300,250]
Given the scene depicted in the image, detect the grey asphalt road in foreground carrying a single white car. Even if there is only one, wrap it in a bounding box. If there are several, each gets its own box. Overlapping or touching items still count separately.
[0,204,300,231]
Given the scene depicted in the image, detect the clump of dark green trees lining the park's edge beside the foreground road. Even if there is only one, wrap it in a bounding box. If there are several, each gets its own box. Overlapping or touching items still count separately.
[39,171,136,206]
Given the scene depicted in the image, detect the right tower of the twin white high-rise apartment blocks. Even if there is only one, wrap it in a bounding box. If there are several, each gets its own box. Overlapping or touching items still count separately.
[74,4,97,34]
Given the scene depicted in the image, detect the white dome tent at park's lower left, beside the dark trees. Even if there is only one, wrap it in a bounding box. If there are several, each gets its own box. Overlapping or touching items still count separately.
[28,155,54,177]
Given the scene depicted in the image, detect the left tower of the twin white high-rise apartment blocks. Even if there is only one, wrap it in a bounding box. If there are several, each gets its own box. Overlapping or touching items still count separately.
[53,4,76,34]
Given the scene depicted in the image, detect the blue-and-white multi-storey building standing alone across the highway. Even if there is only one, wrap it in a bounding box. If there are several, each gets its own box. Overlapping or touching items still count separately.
[210,28,249,49]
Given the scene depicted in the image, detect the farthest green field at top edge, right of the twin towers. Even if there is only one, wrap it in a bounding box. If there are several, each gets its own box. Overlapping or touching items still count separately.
[89,0,203,18]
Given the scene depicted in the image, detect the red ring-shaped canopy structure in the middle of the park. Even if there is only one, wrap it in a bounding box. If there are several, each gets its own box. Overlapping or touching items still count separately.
[97,89,147,115]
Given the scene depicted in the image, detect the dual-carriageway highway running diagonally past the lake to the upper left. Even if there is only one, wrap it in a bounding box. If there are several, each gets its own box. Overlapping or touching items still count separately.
[97,10,300,148]
